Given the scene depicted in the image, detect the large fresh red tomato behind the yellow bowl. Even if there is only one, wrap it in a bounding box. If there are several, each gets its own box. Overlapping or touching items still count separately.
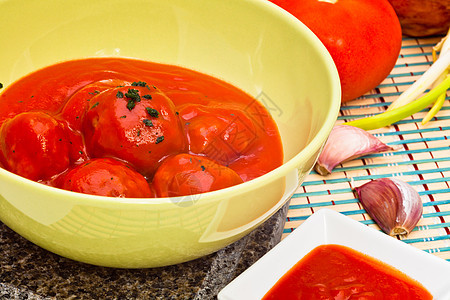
[270,0,402,102]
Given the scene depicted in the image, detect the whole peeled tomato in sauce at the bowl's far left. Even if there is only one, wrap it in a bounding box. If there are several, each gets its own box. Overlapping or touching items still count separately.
[0,112,70,181]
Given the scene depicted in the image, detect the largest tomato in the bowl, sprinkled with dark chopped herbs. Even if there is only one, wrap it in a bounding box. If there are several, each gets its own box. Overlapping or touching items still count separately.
[83,86,186,177]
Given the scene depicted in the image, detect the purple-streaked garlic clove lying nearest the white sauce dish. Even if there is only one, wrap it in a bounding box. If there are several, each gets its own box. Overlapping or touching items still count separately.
[355,178,423,236]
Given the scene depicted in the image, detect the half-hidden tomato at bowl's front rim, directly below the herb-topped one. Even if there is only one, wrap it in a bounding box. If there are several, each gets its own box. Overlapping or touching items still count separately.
[57,158,154,198]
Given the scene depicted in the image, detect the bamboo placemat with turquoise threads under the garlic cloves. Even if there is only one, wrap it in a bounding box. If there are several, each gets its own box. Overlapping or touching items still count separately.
[282,37,450,261]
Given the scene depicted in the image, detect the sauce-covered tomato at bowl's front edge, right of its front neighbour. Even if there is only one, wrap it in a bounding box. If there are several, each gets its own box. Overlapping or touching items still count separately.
[152,153,243,197]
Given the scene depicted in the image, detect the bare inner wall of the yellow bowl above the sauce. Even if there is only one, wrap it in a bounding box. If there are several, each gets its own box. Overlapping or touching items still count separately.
[0,0,337,168]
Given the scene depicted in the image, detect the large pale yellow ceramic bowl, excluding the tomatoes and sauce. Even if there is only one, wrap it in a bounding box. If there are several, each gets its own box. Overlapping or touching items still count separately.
[0,0,340,268]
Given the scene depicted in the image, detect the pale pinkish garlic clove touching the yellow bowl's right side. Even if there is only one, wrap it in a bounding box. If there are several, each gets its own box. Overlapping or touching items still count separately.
[314,125,393,175]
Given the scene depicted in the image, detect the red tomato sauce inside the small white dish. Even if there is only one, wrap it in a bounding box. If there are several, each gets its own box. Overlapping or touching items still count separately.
[263,244,433,300]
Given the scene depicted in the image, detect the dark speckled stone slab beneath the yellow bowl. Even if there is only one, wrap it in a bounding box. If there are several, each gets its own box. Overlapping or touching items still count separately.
[0,205,287,300]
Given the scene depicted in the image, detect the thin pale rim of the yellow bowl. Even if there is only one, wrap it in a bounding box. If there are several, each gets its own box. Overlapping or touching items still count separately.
[0,0,341,205]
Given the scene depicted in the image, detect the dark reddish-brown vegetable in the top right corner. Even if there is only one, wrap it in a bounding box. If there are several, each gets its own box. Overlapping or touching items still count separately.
[389,0,450,37]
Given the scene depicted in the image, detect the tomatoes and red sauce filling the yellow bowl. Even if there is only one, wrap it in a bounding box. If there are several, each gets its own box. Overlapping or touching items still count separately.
[0,58,283,197]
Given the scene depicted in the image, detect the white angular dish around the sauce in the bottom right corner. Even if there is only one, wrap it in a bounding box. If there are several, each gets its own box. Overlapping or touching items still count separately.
[218,208,450,300]
